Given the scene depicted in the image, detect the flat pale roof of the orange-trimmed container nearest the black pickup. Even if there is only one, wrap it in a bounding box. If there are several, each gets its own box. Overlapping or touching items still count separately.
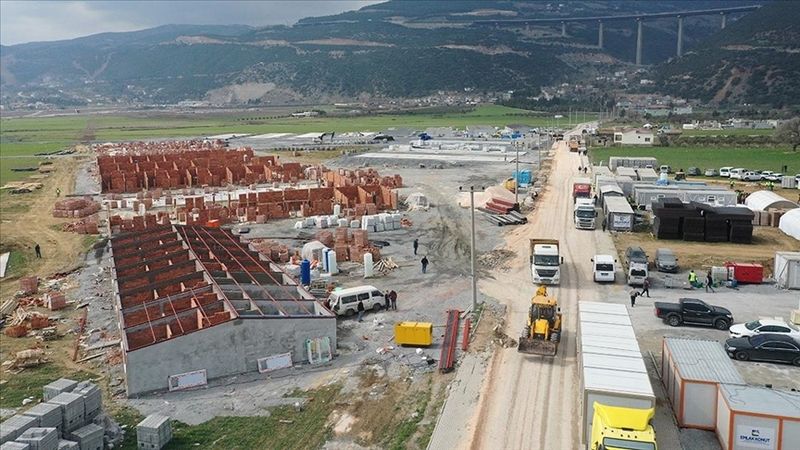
[664,337,744,384]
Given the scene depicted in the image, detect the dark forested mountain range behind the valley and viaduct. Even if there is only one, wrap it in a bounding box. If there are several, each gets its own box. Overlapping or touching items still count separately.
[0,0,799,109]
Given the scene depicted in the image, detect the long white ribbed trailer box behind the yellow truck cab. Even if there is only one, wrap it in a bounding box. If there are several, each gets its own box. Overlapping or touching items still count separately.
[578,302,656,447]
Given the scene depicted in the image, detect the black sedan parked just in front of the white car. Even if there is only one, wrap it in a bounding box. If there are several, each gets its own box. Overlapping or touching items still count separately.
[725,333,800,366]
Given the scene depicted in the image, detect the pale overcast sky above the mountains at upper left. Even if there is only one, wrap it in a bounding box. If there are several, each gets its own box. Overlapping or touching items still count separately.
[0,0,379,45]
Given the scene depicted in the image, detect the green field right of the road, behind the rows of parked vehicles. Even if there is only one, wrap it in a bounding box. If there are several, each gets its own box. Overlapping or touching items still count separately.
[589,146,800,174]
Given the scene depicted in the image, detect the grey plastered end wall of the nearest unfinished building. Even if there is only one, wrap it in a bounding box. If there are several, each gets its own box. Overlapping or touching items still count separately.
[126,317,336,396]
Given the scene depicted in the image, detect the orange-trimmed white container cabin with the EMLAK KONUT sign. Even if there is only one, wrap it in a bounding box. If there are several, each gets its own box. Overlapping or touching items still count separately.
[716,384,800,450]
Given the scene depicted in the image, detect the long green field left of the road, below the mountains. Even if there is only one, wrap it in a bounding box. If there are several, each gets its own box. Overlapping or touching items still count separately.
[0,105,597,184]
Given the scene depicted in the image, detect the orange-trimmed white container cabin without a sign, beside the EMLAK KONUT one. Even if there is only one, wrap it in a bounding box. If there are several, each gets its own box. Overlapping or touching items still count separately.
[661,337,745,430]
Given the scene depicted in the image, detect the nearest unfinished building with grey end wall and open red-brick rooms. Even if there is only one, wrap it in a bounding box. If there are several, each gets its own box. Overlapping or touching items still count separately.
[111,225,336,396]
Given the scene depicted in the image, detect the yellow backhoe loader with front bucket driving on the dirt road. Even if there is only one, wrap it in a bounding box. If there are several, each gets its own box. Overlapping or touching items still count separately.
[517,286,561,356]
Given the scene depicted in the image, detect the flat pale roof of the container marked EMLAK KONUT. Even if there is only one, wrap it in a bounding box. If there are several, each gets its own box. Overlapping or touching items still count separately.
[720,384,800,419]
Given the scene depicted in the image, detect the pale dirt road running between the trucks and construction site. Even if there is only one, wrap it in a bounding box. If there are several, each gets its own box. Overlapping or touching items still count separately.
[461,125,613,450]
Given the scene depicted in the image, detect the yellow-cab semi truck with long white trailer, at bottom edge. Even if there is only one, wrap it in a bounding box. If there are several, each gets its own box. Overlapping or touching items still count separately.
[578,302,657,450]
